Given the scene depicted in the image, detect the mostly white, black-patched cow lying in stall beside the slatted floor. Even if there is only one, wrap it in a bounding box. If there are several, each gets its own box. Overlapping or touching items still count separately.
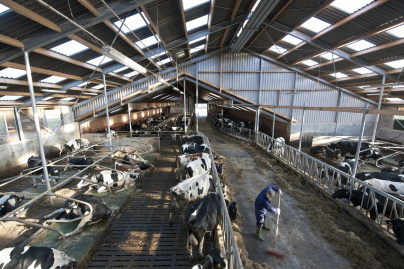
[77,170,141,193]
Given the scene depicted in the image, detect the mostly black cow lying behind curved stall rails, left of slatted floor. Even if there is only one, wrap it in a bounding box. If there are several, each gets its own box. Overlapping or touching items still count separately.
[43,194,112,237]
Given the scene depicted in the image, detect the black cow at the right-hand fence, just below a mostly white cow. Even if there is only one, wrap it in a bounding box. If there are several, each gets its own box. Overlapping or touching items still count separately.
[332,188,402,220]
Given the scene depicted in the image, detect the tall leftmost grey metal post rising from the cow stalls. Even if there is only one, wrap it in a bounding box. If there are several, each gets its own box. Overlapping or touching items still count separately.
[24,51,53,205]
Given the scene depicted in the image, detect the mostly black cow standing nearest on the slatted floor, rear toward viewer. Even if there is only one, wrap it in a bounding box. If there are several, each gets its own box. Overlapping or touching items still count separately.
[185,193,222,261]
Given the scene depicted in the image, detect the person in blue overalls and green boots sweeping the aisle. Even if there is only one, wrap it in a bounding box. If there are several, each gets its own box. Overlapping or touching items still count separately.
[254,185,282,241]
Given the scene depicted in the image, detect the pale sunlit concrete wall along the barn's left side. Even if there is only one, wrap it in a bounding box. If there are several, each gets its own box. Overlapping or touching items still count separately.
[0,107,76,175]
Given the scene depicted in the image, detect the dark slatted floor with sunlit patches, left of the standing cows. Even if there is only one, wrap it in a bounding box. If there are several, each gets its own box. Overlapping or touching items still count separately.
[87,141,204,268]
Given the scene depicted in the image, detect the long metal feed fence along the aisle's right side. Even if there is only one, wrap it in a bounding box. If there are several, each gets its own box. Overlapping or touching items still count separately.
[209,114,404,230]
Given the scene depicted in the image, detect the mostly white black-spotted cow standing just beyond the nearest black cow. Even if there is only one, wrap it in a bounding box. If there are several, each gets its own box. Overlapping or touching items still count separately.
[169,174,215,224]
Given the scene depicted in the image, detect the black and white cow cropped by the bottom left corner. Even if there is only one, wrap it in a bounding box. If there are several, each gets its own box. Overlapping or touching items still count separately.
[0,246,76,269]
